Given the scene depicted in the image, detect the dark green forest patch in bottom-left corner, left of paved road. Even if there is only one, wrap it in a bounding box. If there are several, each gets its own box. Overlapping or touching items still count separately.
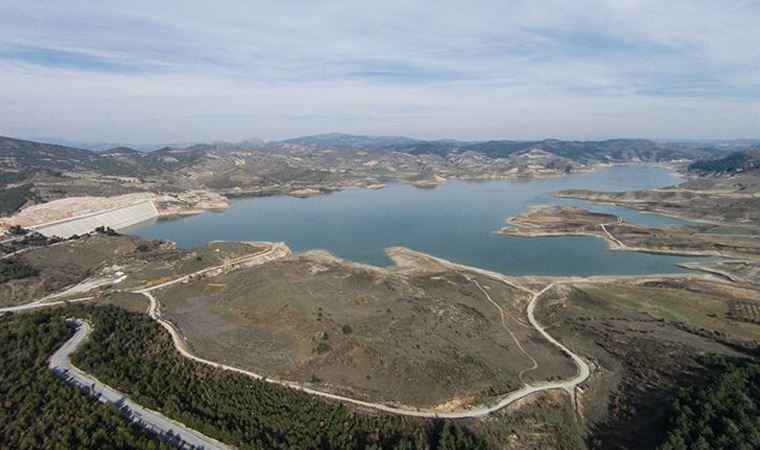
[0,311,171,450]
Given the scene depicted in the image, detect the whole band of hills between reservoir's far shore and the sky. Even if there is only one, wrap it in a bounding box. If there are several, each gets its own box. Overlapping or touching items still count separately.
[0,133,748,218]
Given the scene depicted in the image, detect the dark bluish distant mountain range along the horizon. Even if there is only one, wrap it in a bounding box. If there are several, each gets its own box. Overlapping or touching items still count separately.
[0,133,748,176]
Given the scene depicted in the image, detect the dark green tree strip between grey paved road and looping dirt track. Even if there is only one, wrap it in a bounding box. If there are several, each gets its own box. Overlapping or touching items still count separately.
[14,305,487,449]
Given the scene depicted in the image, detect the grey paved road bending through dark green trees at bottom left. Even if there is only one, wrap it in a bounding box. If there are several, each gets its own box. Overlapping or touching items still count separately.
[48,320,231,450]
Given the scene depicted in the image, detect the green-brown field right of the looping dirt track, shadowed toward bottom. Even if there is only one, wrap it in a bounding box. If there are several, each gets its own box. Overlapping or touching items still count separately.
[536,279,760,448]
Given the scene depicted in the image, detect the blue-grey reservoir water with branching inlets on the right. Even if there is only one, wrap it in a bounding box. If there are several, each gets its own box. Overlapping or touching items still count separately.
[129,165,696,275]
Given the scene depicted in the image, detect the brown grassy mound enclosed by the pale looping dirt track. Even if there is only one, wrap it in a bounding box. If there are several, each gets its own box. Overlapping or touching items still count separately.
[158,254,576,408]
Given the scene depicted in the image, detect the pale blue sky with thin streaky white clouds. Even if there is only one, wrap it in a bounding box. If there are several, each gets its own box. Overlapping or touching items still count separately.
[0,0,760,143]
